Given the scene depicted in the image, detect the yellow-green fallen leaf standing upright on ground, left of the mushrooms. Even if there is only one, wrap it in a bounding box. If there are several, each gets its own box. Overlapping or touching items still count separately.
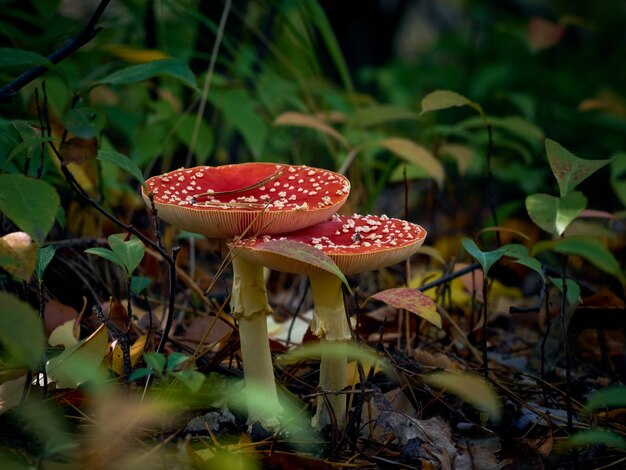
[46,325,109,388]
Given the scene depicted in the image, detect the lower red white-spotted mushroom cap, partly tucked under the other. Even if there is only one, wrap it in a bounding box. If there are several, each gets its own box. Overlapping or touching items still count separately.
[234,214,426,274]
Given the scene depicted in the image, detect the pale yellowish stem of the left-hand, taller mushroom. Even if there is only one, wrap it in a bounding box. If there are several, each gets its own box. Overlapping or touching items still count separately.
[230,254,280,429]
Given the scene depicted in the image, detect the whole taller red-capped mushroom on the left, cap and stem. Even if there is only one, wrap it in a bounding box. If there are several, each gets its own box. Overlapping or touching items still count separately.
[142,163,350,428]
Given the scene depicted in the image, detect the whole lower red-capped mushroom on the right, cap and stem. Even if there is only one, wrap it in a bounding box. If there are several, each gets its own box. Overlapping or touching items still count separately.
[235,214,426,428]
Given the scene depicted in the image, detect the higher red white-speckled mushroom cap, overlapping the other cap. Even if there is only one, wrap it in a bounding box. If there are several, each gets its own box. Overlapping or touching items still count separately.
[142,163,350,238]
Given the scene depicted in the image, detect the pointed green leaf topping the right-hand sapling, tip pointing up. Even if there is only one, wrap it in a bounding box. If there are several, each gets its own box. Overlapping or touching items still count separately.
[546,139,611,197]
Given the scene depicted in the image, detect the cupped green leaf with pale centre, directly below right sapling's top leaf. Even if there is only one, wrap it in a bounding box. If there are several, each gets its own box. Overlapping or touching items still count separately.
[526,191,587,236]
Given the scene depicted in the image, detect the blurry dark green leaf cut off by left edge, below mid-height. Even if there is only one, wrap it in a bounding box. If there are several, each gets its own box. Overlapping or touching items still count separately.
[0,292,46,370]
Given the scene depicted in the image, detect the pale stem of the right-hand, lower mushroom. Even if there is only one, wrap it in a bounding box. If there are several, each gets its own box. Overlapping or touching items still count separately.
[309,272,352,429]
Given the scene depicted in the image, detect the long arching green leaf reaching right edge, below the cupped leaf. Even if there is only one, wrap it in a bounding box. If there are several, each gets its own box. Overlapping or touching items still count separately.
[533,237,624,280]
